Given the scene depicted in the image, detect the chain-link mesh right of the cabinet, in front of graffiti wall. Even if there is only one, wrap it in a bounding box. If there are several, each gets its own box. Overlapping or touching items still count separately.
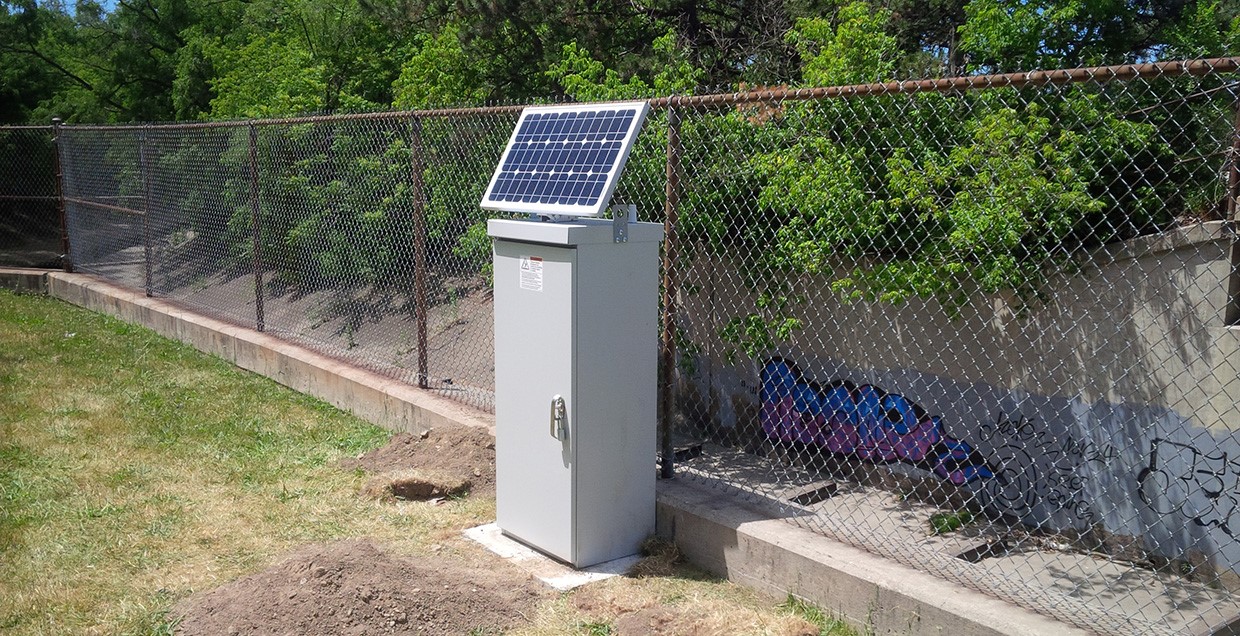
[659,60,1240,634]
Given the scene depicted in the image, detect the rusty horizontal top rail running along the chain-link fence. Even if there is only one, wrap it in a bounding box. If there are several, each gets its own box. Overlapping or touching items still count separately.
[0,56,1240,130]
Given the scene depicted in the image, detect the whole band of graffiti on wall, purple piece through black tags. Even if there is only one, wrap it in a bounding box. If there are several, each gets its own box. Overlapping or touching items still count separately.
[759,358,1240,542]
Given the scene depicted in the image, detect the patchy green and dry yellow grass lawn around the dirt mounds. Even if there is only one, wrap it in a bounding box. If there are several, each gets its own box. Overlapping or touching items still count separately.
[0,290,851,635]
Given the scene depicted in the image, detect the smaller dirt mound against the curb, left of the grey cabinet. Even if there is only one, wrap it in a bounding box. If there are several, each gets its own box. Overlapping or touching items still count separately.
[341,426,495,495]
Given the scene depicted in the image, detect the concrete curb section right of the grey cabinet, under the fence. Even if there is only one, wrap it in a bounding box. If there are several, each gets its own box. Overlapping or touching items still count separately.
[657,480,1089,636]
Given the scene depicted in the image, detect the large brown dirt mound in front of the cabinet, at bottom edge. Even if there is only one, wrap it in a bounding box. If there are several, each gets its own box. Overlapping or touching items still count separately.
[172,539,542,636]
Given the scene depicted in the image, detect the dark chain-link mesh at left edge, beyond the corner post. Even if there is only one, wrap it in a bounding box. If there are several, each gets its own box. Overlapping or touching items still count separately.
[0,126,62,268]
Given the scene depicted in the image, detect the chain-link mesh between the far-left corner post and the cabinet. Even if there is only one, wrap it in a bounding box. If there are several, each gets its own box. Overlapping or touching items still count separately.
[61,108,517,409]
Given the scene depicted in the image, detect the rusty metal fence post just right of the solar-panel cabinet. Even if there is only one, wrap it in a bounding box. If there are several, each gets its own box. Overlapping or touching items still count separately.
[658,107,681,480]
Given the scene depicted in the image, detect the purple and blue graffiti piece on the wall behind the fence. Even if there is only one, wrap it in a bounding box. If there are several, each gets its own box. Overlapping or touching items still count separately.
[760,358,994,485]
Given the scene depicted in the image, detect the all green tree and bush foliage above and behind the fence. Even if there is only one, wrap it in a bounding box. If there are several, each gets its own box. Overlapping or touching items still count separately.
[9,0,1240,366]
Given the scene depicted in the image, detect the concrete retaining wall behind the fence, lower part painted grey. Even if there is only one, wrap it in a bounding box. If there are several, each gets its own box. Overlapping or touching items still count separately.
[678,223,1240,575]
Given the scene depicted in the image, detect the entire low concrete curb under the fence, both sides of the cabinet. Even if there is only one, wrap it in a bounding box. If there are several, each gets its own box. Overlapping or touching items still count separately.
[21,270,1086,636]
